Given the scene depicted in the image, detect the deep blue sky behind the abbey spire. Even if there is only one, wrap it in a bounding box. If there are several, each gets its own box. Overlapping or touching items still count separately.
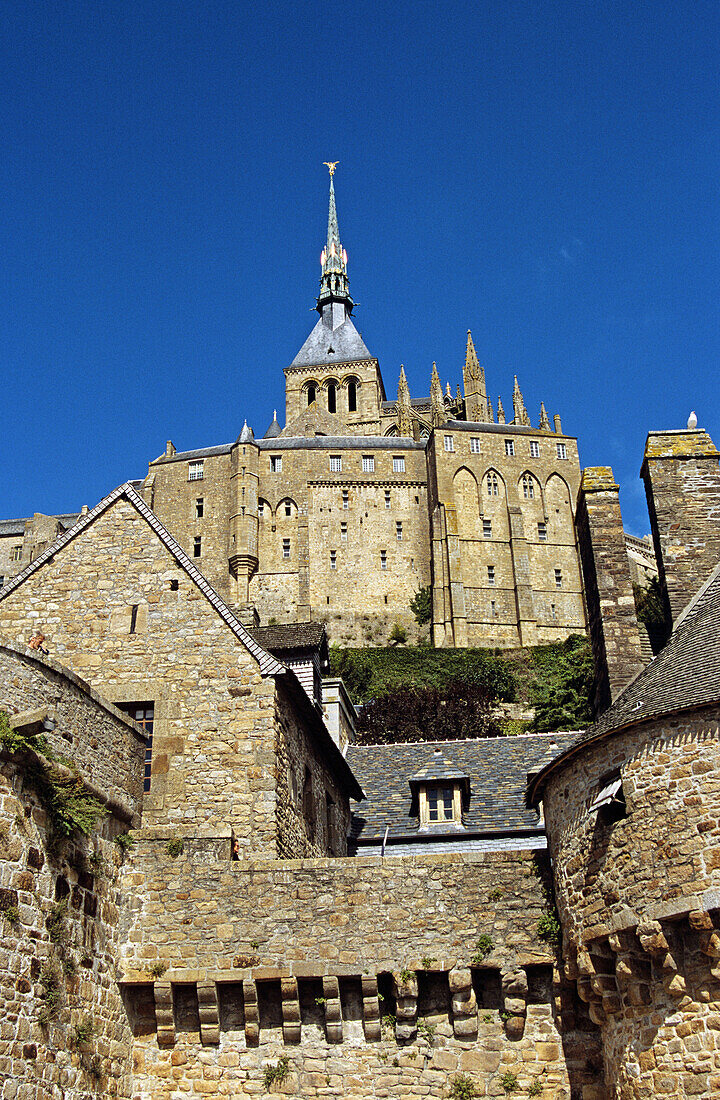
[0,0,720,535]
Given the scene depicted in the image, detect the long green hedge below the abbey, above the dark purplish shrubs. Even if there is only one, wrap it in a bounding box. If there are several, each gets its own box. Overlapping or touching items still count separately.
[330,646,516,703]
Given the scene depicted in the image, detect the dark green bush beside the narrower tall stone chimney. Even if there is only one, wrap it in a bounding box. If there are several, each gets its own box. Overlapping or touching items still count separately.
[530,634,595,732]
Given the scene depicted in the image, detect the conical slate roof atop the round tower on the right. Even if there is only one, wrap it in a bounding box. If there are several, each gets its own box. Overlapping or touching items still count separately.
[528,565,720,800]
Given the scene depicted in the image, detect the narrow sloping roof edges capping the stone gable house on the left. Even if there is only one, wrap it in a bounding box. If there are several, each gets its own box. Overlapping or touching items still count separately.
[0,482,287,677]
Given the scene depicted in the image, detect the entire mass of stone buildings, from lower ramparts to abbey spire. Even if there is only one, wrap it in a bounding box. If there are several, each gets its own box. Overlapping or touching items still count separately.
[0,175,720,1100]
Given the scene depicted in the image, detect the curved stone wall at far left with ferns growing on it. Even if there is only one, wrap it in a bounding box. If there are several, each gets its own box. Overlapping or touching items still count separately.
[0,646,144,1100]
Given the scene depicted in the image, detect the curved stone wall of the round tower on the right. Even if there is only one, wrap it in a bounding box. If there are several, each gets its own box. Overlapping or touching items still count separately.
[544,707,720,1100]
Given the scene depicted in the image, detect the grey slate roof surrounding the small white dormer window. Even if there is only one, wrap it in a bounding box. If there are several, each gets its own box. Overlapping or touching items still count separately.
[346,734,576,846]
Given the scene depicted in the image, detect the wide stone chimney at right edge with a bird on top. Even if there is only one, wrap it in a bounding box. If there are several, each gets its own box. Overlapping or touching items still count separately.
[641,428,720,622]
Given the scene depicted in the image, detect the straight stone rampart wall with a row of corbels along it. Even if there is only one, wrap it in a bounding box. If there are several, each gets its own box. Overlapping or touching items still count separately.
[117,838,605,1100]
